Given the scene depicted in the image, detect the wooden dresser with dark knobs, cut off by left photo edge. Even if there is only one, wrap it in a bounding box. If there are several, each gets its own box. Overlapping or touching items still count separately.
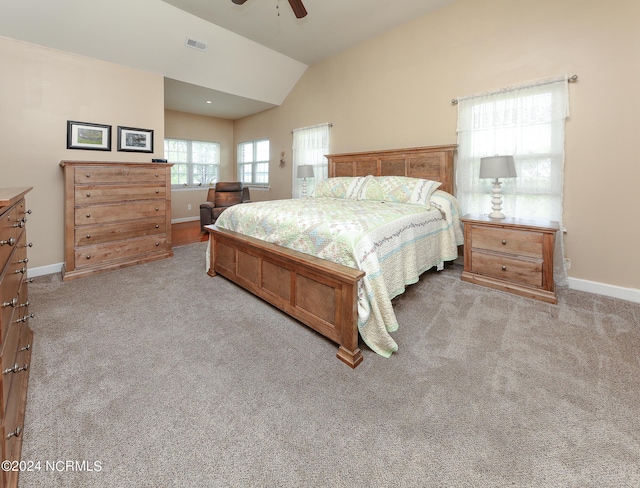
[0,188,33,486]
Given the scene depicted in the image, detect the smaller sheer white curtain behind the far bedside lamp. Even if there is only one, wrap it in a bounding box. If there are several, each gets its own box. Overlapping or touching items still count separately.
[291,123,331,198]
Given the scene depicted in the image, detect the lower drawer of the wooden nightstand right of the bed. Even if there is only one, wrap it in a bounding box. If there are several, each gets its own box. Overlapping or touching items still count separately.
[471,252,542,287]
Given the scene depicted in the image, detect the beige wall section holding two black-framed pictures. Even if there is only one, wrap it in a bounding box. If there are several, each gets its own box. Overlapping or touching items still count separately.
[0,37,164,268]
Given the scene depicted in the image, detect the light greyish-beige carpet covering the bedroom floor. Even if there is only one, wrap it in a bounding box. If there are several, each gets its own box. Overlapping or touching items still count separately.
[20,243,640,488]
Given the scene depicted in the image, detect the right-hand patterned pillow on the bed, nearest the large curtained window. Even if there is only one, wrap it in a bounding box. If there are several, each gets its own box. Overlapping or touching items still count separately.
[359,176,442,209]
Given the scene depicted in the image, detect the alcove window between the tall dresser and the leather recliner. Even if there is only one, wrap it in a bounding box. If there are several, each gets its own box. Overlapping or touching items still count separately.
[164,139,220,186]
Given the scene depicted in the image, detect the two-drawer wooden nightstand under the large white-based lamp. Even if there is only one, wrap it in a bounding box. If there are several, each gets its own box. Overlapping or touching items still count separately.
[461,215,560,303]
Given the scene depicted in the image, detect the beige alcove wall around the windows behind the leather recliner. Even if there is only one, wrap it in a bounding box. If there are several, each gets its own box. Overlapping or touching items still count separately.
[164,110,235,220]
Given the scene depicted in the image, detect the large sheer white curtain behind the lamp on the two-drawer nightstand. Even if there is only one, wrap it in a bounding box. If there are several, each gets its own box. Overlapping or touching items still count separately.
[456,76,569,285]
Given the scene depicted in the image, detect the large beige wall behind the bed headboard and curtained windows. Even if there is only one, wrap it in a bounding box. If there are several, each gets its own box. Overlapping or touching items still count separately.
[234,0,640,289]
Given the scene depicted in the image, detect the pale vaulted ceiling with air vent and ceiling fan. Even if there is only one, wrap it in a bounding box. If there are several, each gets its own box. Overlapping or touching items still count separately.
[0,0,455,119]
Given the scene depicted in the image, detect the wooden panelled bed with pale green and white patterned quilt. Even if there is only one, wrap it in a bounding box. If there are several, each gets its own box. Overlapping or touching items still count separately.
[206,145,462,368]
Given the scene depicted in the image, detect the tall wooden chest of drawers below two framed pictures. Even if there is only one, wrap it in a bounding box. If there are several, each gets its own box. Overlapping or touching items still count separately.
[60,161,173,281]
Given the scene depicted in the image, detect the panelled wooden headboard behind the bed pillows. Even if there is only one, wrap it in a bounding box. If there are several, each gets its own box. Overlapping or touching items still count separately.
[326,144,458,195]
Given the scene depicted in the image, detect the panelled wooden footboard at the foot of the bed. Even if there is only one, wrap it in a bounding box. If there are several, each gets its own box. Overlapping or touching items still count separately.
[206,225,365,368]
